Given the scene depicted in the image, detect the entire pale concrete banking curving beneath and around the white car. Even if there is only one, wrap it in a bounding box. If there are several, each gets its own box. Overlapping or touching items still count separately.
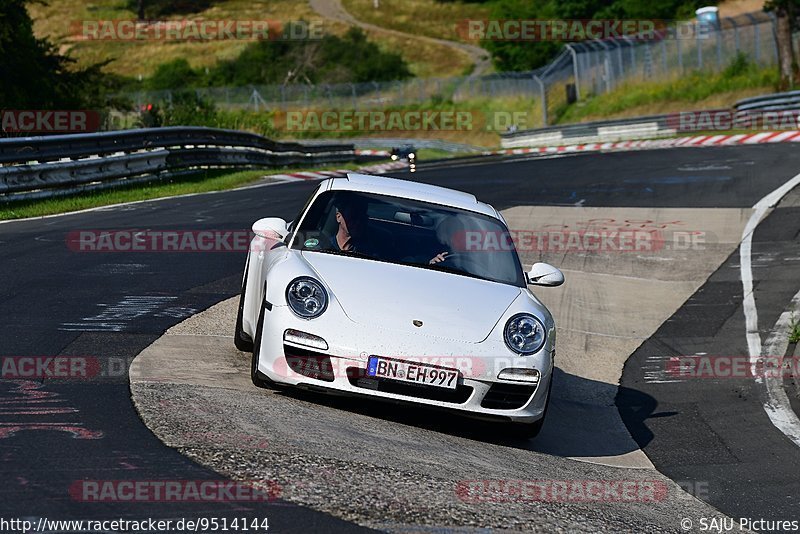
[130,206,751,531]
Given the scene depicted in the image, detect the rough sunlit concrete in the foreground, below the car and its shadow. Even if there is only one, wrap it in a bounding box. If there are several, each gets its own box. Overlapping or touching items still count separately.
[131,308,722,532]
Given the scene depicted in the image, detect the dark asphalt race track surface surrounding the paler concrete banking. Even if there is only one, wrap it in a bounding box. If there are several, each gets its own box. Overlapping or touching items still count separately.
[0,145,800,532]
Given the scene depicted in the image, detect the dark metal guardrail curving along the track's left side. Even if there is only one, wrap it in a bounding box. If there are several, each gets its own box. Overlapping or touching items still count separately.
[0,127,356,202]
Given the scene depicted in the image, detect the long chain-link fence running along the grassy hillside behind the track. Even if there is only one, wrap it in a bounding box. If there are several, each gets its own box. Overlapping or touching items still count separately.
[118,12,778,128]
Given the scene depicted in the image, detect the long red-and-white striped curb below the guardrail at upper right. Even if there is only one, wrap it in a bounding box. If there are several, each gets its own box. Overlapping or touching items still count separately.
[494,130,800,155]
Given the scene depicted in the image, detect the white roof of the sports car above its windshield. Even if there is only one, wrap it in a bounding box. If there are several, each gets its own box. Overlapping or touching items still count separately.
[329,172,499,218]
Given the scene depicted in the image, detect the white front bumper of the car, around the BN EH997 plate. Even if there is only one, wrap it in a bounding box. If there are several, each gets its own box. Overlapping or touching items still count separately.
[258,306,555,423]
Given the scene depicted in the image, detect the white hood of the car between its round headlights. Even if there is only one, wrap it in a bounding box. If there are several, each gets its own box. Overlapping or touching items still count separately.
[302,252,520,343]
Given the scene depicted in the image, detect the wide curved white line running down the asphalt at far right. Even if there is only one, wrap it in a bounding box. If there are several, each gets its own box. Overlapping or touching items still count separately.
[739,174,800,446]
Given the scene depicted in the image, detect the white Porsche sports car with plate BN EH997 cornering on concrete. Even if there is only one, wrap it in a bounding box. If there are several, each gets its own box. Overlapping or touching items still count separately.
[234,174,564,436]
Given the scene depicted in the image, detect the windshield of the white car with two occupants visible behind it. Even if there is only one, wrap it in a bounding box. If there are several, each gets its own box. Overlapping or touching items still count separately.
[292,191,525,287]
